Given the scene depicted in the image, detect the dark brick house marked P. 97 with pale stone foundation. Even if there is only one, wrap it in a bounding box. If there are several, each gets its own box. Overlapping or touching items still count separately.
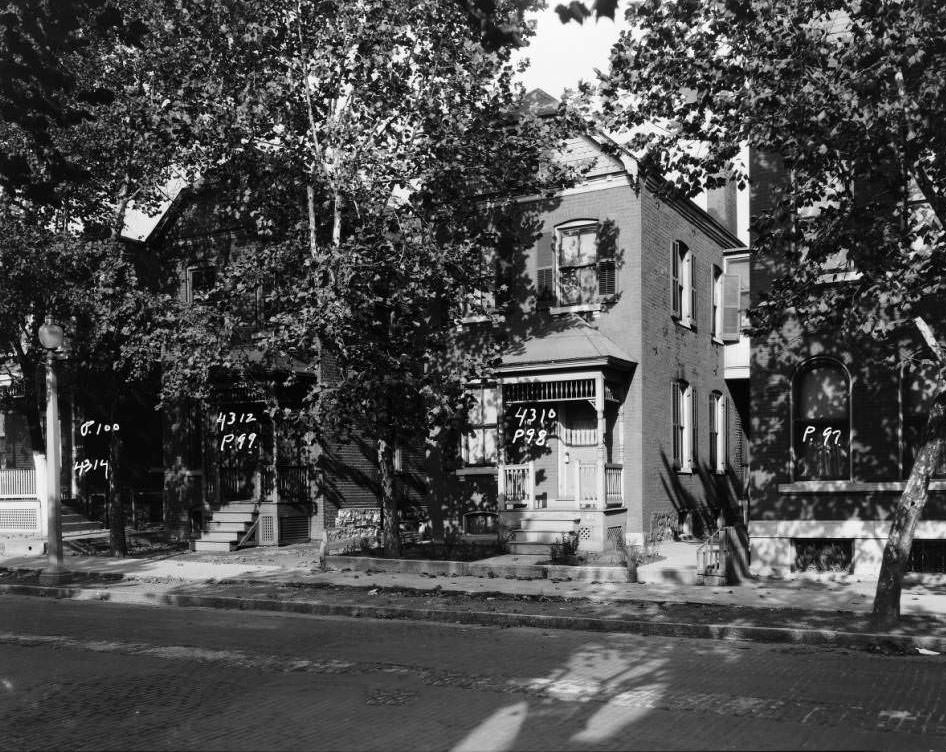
[749,153,946,575]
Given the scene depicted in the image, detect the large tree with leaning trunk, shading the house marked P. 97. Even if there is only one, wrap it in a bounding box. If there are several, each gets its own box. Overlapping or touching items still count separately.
[584,0,946,621]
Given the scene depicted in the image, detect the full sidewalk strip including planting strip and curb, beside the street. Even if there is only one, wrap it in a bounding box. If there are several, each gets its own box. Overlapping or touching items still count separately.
[0,544,946,652]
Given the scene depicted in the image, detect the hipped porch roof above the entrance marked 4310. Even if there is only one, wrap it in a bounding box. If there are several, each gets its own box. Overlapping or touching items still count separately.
[496,317,636,373]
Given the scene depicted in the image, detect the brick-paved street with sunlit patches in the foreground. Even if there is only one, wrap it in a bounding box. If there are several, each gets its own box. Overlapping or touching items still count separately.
[0,596,946,752]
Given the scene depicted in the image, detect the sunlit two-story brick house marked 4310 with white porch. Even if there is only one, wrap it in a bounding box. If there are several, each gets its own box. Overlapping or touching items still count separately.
[436,93,747,550]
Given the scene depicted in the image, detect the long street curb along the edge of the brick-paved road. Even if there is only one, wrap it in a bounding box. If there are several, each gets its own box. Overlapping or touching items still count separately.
[0,585,946,653]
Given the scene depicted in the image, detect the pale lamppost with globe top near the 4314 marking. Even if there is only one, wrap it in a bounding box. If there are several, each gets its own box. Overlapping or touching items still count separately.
[39,316,68,585]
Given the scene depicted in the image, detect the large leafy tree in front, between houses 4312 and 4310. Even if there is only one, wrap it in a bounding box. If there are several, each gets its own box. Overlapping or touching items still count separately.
[159,0,557,554]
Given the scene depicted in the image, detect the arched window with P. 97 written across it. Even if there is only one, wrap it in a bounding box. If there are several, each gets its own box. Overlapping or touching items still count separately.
[794,358,851,480]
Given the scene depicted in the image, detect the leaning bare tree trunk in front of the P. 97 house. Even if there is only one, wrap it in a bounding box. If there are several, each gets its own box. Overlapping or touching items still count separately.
[873,392,946,626]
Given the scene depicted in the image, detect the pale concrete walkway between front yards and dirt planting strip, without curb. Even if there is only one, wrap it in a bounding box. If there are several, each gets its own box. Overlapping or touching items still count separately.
[0,544,946,634]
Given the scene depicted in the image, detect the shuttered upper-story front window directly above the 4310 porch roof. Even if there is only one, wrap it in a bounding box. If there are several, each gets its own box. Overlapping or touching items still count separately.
[537,220,616,306]
